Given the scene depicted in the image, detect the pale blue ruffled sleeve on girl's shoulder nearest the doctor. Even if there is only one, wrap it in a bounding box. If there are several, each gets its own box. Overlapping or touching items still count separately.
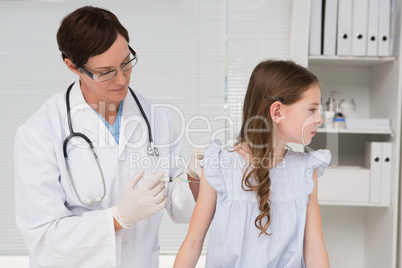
[204,140,226,195]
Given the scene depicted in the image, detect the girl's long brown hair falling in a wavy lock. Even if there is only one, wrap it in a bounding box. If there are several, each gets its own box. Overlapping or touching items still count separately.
[236,60,320,236]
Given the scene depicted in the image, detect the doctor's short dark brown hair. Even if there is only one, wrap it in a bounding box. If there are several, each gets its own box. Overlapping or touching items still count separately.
[57,6,129,67]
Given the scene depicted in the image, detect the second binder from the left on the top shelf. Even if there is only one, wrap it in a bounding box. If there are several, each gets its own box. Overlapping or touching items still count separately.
[323,0,338,56]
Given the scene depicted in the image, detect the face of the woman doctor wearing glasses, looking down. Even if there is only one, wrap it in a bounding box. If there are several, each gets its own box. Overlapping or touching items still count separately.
[78,34,131,105]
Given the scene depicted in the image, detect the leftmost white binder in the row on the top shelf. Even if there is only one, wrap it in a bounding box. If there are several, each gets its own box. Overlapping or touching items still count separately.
[309,0,323,55]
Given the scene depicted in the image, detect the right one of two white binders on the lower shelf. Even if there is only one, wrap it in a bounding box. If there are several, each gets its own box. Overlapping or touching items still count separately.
[381,142,392,203]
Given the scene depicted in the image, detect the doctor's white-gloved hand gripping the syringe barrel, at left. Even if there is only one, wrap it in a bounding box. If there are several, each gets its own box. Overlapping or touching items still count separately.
[113,170,167,228]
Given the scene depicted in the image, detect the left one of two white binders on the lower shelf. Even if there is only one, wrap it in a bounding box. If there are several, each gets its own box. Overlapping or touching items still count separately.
[366,142,382,203]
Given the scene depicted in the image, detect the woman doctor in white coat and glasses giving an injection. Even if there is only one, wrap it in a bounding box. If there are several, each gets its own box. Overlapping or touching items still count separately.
[15,6,204,268]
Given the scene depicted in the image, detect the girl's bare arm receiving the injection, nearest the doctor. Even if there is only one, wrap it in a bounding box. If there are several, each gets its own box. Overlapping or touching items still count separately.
[174,171,216,268]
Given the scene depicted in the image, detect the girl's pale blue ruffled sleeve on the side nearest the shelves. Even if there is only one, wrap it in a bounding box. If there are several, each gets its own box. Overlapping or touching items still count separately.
[304,150,331,195]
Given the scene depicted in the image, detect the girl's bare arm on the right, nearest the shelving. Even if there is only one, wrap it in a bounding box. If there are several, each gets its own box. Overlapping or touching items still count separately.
[304,169,329,268]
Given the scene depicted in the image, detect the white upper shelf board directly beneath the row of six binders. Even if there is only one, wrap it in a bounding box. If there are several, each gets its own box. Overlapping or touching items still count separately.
[308,56,396,67]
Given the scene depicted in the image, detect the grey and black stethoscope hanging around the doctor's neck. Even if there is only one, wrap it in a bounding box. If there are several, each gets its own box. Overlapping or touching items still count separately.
[63,83,159,206]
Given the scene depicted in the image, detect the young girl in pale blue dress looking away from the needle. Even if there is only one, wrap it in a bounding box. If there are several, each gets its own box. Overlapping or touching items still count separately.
[174,60,331,268]
